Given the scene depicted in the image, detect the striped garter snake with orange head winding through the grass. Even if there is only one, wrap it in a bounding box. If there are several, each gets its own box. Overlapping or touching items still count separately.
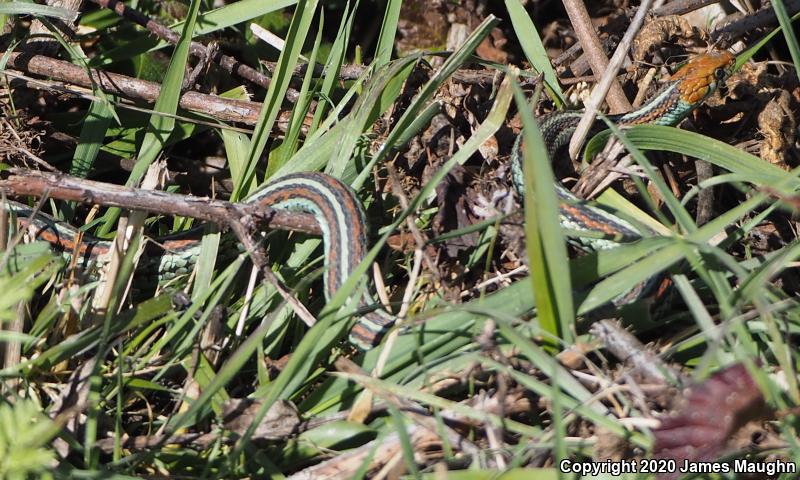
[4,51,735,350]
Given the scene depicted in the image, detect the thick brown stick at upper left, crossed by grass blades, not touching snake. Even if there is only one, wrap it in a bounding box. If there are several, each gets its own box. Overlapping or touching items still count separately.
[3,53,262,125]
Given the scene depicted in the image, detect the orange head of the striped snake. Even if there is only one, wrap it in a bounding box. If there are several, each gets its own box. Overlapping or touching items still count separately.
[670,51,736,105]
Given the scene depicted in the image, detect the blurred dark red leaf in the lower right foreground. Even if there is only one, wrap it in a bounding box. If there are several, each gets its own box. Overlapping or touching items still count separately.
[653,363,768,480]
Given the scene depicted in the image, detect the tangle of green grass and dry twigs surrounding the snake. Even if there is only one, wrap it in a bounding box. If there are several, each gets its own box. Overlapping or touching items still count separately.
[0,0,800,480]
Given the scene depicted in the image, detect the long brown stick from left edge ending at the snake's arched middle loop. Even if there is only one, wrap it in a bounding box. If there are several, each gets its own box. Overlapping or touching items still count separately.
[0,169,322,235]
